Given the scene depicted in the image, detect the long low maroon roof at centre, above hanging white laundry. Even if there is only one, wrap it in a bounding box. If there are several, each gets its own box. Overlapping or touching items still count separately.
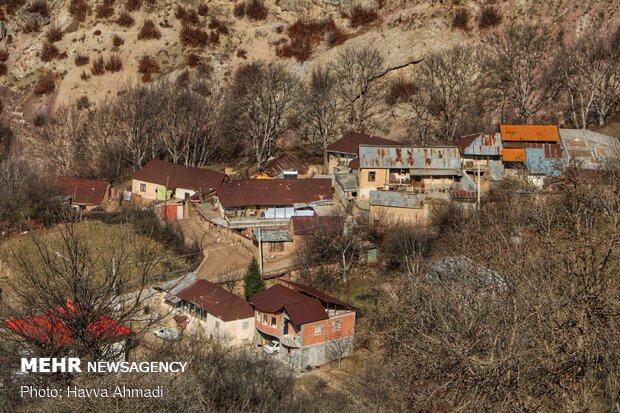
[217,179,333,208]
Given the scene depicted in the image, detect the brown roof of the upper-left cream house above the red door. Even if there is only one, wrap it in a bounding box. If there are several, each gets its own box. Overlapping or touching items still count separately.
[132,159,226,193]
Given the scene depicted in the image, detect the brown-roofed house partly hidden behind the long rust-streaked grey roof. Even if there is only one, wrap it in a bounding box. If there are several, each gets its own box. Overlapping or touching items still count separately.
[325,132,400,174]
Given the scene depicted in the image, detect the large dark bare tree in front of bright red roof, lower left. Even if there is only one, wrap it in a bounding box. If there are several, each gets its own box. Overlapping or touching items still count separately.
[3,222,165,360]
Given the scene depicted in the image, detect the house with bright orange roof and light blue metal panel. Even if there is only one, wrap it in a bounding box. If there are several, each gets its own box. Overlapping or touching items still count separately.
[500,125,562,176]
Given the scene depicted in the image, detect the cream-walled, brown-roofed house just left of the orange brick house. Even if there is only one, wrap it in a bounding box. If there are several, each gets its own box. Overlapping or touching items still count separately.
[156,273,254,346]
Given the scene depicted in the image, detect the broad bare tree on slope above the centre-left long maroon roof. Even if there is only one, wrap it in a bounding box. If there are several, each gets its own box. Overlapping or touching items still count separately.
[225,63,299,167]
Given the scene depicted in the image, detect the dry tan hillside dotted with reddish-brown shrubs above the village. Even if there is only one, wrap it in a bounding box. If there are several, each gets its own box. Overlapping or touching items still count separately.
[0,0,620,131]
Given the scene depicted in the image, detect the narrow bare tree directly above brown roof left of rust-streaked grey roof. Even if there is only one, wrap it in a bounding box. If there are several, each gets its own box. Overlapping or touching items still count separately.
[331,46,385,131]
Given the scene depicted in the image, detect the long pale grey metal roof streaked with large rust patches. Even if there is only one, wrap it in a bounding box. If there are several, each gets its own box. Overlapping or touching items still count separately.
[359,145,461,173]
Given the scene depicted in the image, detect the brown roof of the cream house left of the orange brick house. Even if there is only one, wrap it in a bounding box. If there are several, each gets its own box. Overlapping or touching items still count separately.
[176,279,254,321]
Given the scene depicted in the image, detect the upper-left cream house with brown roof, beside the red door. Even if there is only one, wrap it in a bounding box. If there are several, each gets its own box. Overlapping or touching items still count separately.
[131,159,226,201]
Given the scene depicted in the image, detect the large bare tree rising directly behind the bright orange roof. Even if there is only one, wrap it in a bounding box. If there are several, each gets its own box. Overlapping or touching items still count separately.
[484,24,560,123]
